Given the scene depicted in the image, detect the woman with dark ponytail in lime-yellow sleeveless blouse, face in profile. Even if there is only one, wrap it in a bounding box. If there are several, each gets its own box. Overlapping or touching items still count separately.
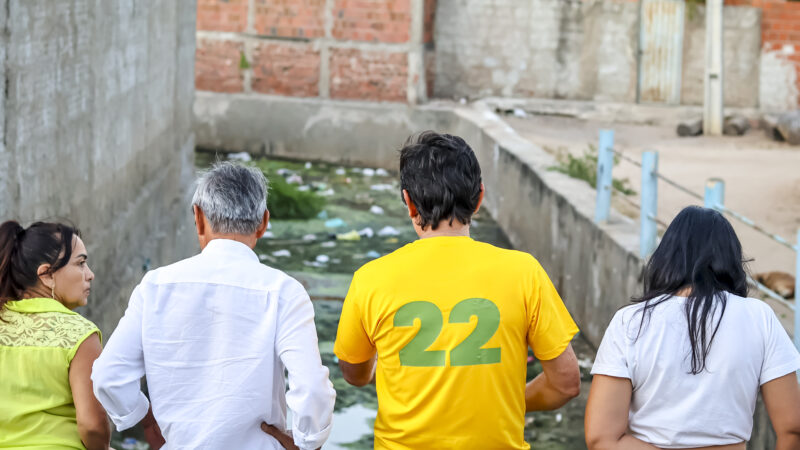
[0,221,111,450]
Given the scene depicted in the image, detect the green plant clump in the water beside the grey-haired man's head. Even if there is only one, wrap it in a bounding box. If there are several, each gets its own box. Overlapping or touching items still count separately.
[265,171,325,220]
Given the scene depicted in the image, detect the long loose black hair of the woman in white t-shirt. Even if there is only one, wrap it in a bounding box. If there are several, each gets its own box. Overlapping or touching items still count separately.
[633,206,747,375]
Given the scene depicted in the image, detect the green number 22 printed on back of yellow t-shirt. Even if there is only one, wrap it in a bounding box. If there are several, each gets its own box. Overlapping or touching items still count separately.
[394,298,500,367]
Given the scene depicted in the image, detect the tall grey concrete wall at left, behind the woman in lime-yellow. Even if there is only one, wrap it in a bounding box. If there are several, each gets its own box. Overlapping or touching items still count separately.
[0,0,196,336]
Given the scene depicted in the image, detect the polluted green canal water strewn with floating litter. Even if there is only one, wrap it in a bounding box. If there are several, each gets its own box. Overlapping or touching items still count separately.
[115,152,594,450]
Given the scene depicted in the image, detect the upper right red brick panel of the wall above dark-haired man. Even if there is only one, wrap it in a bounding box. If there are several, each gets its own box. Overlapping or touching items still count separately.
[333,0,411,43]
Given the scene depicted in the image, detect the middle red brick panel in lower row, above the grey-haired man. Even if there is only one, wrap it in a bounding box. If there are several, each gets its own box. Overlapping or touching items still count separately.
[252,42,320,97]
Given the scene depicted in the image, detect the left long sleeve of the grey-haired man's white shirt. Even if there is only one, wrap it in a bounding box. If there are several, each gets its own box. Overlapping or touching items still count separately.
[92,285,150,431]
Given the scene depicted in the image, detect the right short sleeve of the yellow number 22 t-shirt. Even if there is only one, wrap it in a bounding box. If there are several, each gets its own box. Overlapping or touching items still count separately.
[528,262,579,361]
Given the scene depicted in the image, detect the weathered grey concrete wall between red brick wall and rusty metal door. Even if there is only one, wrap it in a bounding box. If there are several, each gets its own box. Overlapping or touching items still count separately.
[434,0,639,102]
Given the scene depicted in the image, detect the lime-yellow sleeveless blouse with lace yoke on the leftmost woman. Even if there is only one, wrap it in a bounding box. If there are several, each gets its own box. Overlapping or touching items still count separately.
[0,298,100,450]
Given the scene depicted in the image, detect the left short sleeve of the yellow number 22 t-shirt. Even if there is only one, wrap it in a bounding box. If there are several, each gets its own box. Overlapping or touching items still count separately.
[333,276,375,364]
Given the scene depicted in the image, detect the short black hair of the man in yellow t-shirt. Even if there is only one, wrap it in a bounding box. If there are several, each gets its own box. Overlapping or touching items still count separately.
[400,131,481,230]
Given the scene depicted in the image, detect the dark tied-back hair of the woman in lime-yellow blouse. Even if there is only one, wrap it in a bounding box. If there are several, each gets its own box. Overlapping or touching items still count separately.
[0,220,80,312]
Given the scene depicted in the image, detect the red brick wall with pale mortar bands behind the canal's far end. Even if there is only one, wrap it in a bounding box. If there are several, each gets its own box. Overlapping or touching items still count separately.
[195,0,435,104]
